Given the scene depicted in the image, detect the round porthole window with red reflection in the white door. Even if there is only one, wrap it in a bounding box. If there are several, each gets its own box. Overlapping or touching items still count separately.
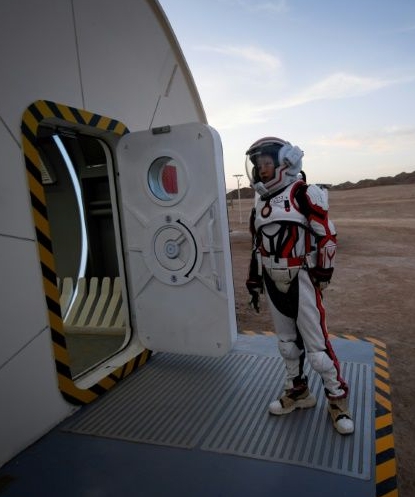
[148,157,186,203]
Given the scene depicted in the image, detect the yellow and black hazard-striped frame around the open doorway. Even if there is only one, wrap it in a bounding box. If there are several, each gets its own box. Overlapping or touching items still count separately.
[21,100,151,404]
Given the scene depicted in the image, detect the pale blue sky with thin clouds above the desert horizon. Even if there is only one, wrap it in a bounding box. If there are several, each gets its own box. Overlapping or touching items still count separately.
[159,0,415,189]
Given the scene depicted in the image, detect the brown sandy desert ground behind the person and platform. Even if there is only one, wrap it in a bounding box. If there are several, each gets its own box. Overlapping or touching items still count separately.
[228,184,415,497]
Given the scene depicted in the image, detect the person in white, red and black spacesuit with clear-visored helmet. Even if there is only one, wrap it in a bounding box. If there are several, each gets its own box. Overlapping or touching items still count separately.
[246,137,354,434]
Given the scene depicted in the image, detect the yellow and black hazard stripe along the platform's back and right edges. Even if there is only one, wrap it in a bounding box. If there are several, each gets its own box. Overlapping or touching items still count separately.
[240,331,398,497]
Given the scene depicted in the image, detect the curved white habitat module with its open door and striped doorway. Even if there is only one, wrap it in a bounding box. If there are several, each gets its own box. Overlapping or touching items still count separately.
[0,0,236,465]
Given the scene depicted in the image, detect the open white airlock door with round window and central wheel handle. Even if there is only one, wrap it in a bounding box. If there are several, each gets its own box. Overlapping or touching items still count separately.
[117,123,236,356]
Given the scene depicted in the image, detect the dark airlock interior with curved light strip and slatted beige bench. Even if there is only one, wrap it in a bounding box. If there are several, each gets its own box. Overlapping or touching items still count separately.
[38,124,129,378]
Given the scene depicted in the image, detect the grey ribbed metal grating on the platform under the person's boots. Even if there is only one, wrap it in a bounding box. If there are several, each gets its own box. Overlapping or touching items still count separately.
[62,353,374,479]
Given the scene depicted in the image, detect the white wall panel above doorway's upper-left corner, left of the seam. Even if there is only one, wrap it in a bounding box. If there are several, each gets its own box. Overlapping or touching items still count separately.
[0,0,82,136]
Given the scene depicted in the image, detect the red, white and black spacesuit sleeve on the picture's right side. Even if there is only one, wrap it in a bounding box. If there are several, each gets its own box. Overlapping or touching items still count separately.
[304,185,337,274]
